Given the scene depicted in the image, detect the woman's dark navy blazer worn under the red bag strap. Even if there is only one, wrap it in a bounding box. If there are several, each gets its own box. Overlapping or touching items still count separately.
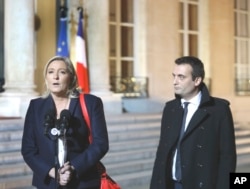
[21,94,109,189]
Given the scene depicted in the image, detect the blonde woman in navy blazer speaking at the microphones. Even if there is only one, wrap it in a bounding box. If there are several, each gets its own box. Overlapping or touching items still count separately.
[21,56,109,189]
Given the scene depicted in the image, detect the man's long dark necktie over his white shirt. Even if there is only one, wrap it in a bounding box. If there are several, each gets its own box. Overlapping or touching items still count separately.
[175,102,189,181]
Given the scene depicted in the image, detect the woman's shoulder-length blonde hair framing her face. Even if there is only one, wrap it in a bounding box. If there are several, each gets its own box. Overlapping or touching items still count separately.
[43,56,79,97]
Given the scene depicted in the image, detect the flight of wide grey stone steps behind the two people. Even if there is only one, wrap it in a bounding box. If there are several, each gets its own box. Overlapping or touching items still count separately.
[0,114,250,189]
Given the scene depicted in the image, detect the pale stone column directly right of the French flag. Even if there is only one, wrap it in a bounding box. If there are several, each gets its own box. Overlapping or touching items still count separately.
[84,0,122,113]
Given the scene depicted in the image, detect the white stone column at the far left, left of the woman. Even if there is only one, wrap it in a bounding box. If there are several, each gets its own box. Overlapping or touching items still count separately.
[0,0,37,117]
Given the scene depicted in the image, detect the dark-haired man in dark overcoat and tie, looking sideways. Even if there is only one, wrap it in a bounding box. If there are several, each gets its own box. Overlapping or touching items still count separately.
[150,56,236,189]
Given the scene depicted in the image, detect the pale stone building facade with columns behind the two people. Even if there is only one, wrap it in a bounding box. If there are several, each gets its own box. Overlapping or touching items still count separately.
[0,0,250,122]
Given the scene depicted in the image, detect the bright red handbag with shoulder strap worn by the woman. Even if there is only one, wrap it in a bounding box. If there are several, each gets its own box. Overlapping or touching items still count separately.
[79,93,121,189]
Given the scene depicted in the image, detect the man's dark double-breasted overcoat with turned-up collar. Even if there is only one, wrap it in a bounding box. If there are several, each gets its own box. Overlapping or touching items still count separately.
[150,85,236,189]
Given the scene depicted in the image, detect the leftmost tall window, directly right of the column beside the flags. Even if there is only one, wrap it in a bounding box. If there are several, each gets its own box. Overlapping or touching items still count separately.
[109,0,134,77]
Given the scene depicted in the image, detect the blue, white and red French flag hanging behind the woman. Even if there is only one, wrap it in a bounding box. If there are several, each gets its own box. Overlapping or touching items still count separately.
[76,8,90,93]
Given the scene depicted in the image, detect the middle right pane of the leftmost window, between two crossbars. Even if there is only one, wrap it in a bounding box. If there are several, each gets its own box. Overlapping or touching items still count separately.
[121,27,133,57]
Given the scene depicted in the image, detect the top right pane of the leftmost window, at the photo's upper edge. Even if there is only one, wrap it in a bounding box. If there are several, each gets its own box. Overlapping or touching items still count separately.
[121,0,134,23]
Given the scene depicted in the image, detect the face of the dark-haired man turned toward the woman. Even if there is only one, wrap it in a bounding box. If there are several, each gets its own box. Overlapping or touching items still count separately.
[173,64,201,100]
